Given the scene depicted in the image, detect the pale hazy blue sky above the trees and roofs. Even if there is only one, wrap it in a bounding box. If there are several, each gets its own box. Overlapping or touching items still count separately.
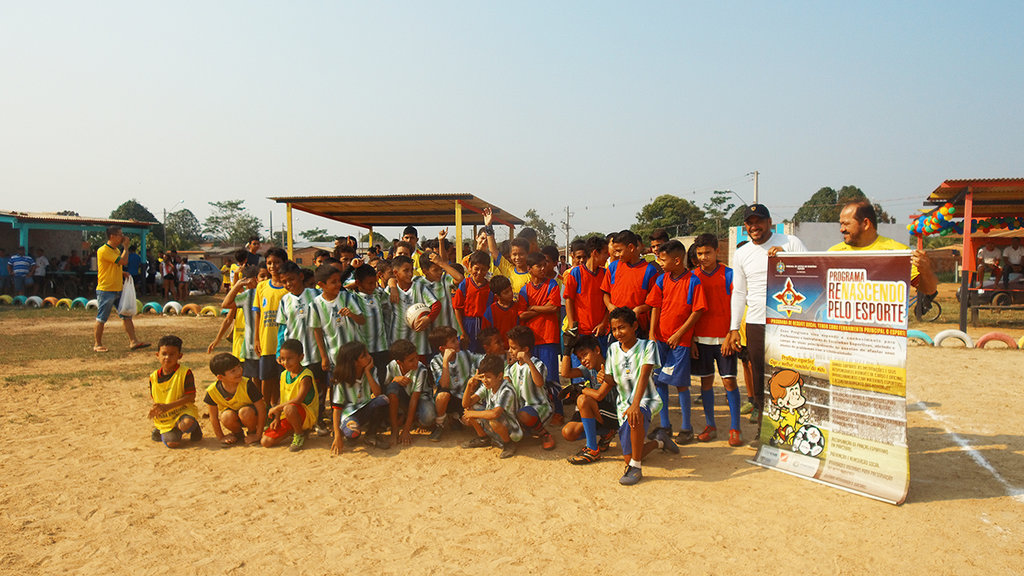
[0,0,1024,240]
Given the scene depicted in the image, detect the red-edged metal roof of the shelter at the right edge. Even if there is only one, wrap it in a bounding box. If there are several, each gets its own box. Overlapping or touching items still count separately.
[925,178,1024,219]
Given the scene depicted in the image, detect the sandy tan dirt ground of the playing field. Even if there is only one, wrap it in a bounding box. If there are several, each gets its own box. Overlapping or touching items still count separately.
[0,306,1024,576]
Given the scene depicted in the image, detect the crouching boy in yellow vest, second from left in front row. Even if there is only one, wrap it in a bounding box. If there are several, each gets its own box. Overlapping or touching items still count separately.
[203,353,266,446]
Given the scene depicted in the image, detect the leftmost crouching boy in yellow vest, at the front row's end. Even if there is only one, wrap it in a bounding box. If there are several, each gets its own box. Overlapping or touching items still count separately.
[150,335,203,448]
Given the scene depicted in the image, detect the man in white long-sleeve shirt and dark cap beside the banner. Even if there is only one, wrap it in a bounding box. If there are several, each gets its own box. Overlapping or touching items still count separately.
[725,204,807,447]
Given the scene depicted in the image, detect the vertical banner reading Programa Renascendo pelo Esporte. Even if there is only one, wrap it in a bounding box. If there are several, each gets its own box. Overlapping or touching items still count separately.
[754,250,911,504]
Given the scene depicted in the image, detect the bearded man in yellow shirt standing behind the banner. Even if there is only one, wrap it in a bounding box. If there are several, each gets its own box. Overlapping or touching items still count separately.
[828,200,939,295]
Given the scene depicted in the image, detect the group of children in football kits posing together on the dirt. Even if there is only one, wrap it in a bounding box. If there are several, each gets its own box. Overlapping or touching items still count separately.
[150,220,741,485]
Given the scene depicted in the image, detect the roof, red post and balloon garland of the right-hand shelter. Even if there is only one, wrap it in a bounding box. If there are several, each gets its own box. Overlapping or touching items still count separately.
[907,178,1024,330]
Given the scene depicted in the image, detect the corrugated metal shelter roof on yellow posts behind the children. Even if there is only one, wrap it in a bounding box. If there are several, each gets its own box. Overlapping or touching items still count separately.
[270,194,523,228]
